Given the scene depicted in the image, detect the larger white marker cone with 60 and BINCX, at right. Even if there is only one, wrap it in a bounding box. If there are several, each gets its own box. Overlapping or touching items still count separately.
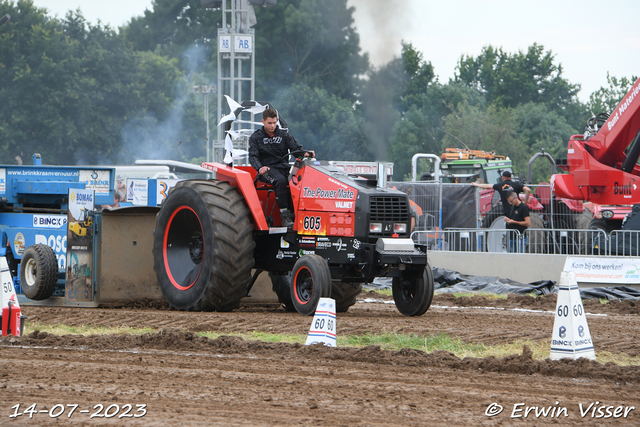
[550,271,596,360]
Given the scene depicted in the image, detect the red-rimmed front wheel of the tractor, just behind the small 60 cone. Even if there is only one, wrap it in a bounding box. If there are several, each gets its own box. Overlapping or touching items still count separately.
[291,255,331,316]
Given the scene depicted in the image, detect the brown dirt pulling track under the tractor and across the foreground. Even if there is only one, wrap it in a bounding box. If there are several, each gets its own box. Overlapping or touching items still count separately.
[0,293,640,426]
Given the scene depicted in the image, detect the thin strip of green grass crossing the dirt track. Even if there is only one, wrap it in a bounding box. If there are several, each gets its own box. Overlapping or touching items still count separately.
[24,322,640,366]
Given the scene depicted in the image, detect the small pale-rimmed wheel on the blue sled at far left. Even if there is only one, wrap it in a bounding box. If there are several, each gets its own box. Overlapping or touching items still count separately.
[20,243,58,301]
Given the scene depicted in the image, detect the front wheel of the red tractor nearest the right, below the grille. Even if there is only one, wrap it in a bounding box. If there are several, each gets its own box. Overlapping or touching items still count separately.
[391,263,435,316]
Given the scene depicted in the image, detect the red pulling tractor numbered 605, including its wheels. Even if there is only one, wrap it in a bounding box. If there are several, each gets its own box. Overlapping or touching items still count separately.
[153,152,434,316]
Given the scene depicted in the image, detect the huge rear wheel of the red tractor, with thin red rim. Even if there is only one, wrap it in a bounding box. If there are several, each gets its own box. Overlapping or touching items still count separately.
[153,180,255,311]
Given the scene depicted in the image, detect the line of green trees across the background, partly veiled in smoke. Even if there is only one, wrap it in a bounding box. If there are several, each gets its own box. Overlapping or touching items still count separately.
[0,0,636,181]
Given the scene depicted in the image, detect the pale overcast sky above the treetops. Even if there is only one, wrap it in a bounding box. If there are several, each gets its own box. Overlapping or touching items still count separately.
[28,0,640,101]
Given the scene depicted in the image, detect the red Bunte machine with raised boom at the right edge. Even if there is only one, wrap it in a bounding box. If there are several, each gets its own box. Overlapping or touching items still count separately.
[552,79,640,242]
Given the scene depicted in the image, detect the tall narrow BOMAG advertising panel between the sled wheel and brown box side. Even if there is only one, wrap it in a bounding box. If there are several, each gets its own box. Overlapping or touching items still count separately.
[65,189,95,302]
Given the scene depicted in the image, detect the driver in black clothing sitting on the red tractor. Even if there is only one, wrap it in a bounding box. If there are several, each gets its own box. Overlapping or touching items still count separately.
[249,108,315,227]
